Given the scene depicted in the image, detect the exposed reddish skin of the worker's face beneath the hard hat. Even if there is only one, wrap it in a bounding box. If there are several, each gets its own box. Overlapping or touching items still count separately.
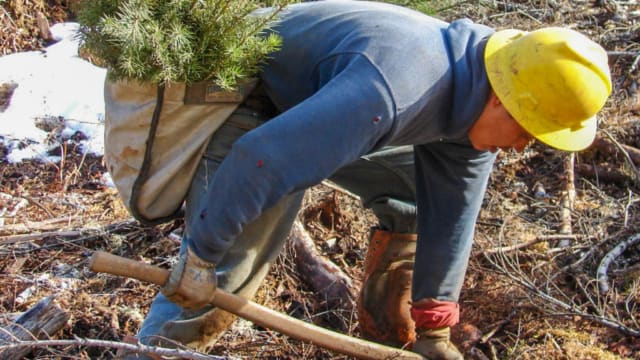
[469,91,534,152]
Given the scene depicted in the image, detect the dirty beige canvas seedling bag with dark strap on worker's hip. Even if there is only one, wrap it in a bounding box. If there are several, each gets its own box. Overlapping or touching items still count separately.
[104,80,255,224]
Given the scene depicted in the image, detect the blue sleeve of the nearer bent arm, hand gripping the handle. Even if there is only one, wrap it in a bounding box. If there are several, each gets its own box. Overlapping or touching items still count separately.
[187,55,395,262]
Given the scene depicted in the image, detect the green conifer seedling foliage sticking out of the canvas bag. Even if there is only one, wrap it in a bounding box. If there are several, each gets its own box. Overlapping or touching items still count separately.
[78,0,291,89]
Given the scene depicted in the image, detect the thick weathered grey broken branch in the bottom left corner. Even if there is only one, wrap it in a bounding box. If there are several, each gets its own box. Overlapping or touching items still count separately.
[0,296,70,360]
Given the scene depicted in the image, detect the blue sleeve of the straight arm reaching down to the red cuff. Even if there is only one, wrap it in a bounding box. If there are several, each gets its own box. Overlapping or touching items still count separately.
[412,142,496,301]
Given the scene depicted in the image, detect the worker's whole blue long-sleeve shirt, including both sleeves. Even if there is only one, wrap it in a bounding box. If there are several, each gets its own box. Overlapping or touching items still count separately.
[190,1,494,297]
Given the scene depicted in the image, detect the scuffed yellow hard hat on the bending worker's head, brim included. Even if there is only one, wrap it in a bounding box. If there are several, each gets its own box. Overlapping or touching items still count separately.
[484,27,611,151]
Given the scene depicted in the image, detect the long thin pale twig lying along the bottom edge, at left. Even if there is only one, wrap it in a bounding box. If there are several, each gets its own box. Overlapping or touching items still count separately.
[0,338,228,360]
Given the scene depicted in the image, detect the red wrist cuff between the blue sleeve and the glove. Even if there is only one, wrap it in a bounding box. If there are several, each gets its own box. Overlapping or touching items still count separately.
[411,299,460,329]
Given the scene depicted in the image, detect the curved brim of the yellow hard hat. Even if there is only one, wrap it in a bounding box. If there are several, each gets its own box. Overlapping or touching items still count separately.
[484,29,597,151]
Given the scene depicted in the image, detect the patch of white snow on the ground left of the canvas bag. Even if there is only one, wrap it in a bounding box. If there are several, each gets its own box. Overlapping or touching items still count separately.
[0,23,106,162]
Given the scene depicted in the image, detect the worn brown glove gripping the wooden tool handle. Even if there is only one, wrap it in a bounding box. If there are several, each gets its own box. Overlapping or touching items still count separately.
[160,247,218,310]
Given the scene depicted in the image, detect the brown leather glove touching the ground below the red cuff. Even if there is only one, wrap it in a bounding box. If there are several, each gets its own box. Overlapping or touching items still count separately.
[412,326,464,360]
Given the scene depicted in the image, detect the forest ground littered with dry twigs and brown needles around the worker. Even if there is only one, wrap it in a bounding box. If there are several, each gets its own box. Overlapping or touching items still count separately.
[0,0,640,359]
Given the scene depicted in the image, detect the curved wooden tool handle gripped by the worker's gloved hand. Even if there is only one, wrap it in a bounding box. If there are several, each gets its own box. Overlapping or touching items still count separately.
[90,251,425,360]
